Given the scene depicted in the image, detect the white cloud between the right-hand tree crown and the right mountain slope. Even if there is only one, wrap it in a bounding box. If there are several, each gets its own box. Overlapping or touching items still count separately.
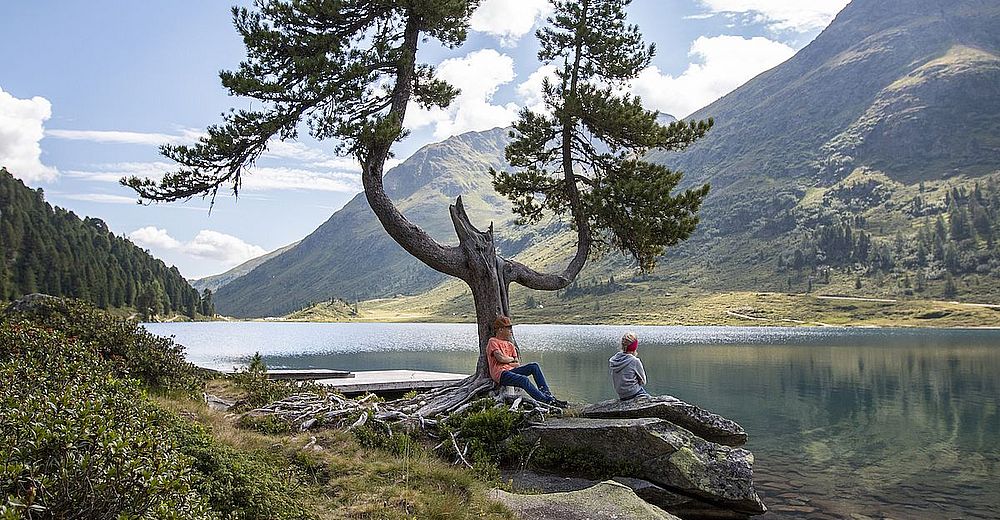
[632,36,795,118]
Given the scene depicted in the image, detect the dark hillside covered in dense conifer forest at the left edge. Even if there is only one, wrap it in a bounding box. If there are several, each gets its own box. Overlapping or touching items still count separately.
[0,168,203,317]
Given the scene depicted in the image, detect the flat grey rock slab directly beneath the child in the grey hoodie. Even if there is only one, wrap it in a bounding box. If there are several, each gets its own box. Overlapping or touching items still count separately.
[580,395,747,446]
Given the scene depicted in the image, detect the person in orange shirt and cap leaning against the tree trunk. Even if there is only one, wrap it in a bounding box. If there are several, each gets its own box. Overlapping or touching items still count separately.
[486,315,566,408]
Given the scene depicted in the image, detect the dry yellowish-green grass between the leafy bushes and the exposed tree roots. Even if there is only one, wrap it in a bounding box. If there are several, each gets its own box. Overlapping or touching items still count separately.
[157,390,514,519]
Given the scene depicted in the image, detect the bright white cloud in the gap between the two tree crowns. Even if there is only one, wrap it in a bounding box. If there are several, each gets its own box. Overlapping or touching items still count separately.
[406,49,518,139]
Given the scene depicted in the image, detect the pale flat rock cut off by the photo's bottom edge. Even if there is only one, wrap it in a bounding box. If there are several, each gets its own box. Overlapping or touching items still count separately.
[490,480,680,520]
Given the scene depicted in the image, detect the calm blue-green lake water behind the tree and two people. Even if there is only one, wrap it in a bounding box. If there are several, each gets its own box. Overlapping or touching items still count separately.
[147,323,1000,519]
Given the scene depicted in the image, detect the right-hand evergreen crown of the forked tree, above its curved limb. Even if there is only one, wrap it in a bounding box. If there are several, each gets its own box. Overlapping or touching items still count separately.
[491,0,712,271]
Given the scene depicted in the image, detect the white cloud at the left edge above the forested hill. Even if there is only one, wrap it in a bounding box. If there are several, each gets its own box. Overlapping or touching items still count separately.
[0,88,59,182]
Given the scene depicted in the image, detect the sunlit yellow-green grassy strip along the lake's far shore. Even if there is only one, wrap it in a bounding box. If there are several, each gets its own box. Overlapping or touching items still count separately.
[284,282,1000,327]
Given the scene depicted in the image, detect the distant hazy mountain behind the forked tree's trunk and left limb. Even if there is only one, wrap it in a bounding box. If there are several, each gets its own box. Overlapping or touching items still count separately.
[214,128,564,316]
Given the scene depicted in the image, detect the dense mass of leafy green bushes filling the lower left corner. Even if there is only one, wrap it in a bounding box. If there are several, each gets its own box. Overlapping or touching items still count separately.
[0,300,310,519]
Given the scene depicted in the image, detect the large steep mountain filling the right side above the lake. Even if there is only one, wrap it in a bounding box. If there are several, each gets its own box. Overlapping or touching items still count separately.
[651,0,1000,295]
